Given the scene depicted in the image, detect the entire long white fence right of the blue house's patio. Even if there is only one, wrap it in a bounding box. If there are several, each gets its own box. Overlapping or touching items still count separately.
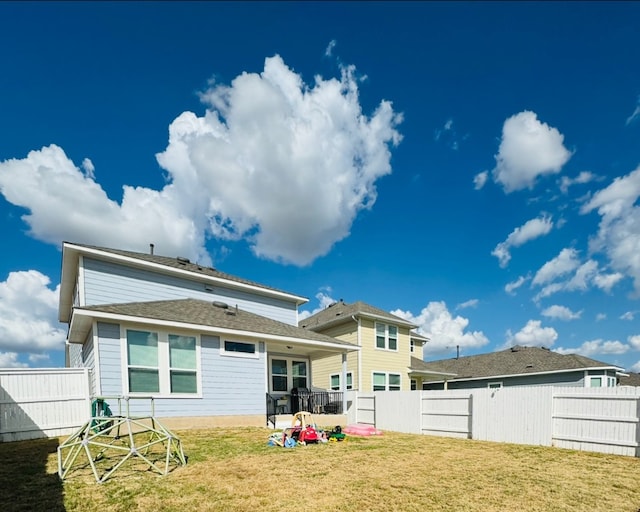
[356,386,640,457]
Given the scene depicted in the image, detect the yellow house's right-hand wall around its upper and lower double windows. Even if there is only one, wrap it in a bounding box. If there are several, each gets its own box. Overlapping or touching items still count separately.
[361,319,411,391]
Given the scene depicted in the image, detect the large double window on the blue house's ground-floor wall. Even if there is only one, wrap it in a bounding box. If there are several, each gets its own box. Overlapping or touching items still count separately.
[126,329,198,395]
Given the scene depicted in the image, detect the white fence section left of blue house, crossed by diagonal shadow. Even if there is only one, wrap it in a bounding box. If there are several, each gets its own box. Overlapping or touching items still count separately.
[0,368,91,441]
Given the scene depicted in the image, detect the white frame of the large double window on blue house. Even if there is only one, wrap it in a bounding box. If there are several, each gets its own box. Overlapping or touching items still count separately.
[120,325,202,398]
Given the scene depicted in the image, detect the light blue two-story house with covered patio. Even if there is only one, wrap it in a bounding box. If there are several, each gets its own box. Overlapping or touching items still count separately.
[59,242,358,426]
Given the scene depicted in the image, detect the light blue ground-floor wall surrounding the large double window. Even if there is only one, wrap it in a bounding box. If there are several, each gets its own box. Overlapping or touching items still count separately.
[98,323,266,418]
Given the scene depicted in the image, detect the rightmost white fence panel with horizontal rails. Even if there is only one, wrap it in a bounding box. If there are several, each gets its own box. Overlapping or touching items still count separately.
[553,387,640,457]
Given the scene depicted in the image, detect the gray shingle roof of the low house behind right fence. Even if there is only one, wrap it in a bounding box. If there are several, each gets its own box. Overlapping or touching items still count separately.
[411,346,619,380]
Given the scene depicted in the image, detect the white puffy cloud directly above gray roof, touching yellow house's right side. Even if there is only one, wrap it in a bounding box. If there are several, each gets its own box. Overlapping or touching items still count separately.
[391,302,489,355]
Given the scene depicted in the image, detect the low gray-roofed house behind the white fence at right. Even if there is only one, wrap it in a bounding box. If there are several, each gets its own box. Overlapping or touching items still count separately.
[411,346,626,390]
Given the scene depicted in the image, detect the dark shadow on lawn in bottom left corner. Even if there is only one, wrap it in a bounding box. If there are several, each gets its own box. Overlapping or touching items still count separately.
[0,438,65,512]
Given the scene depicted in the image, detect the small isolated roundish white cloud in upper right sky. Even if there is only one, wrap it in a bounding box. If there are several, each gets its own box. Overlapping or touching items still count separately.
[492,111,571,193]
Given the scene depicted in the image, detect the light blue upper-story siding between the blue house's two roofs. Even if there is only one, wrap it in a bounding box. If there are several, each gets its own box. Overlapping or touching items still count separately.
[83,256,298,325]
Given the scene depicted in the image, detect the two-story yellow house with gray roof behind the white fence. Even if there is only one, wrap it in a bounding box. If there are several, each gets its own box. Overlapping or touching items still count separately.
[298,300,429,391]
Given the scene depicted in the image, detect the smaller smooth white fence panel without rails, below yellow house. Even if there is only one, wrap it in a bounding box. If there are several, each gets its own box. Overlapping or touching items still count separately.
[375,391,421,434]
